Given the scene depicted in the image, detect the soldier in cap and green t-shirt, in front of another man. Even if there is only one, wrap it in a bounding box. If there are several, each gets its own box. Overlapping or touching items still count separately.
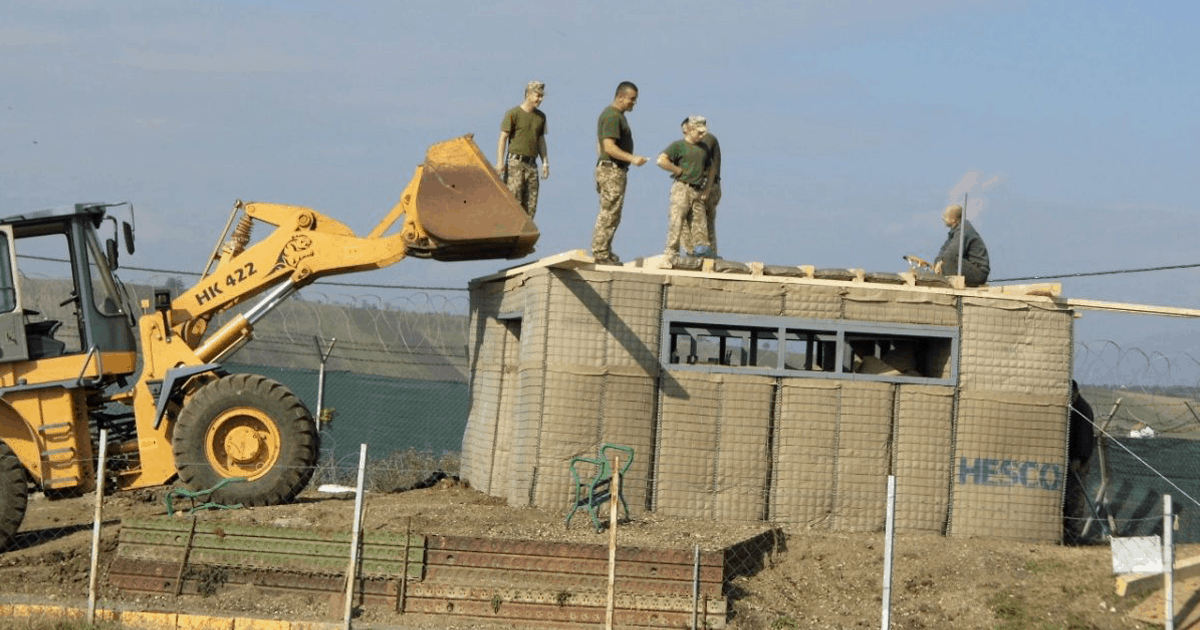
[656,116,708,268]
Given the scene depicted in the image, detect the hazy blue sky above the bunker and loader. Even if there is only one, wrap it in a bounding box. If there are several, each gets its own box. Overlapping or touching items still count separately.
[0,0,1200,372]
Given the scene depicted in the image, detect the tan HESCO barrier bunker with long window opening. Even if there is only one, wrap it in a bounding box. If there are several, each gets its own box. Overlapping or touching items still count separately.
[462,257,1073,540]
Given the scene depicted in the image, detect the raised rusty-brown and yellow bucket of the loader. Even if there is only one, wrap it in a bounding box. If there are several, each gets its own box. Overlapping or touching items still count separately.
[408,134,540,260]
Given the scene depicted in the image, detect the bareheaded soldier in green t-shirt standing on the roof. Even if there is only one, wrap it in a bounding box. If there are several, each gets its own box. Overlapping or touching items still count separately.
[592,80,647,265]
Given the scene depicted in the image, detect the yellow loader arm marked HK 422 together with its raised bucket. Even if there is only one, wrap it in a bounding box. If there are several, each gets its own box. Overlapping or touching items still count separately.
[159,136,539,350]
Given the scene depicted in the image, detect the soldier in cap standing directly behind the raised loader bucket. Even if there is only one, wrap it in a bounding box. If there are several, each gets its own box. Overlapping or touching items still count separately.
[496,80,550,218]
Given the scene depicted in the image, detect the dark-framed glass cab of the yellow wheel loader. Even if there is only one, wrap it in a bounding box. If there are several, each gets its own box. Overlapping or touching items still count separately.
[0,204,137,364]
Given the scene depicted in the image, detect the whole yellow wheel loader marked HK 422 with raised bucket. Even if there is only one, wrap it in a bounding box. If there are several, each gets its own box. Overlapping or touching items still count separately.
[0,136,539,548]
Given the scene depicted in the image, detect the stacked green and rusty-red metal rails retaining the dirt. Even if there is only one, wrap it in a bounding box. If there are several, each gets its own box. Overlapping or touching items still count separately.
[108,518,758,629]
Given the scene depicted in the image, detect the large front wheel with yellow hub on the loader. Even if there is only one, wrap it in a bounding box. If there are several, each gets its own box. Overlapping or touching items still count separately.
[172,374,319,506]
